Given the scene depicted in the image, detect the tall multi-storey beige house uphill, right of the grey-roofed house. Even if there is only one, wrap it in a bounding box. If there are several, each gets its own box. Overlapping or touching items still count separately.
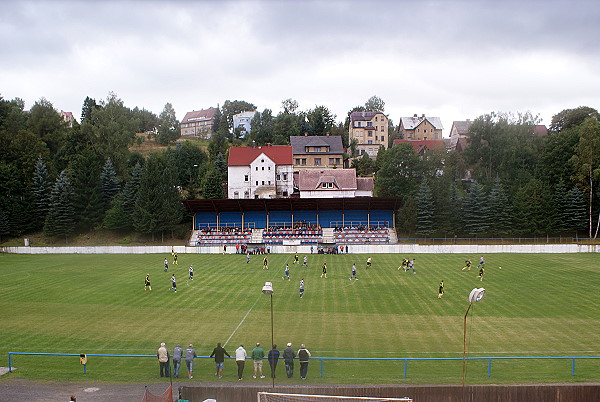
[348,111,389,158]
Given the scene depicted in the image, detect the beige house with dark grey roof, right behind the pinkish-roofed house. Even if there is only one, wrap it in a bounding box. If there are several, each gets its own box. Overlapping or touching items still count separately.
[290,135,344,171]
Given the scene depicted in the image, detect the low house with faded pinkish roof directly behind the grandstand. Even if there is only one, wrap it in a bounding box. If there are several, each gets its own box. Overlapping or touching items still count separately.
[294,169,373,198]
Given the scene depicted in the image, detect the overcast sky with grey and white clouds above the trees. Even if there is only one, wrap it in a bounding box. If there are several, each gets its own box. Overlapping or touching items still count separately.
[0,0,600,132]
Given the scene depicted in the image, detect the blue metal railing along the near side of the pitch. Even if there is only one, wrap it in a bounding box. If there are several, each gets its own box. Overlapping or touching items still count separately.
[8,352,600,378]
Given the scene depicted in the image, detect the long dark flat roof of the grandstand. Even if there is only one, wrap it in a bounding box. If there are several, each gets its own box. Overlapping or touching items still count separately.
[183,197,400,213]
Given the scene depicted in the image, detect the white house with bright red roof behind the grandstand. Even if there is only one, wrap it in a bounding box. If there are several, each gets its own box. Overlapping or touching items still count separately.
[227,145,294,198]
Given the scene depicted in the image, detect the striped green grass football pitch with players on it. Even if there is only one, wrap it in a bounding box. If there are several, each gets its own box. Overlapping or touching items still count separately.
[0,254,600,384]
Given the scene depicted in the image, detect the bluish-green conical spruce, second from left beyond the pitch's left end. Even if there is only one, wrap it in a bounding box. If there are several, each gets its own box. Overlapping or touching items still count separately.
[44,170,75,240]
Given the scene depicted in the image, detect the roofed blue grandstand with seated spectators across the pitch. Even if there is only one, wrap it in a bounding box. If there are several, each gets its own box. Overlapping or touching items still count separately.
[184,197,399,247]
